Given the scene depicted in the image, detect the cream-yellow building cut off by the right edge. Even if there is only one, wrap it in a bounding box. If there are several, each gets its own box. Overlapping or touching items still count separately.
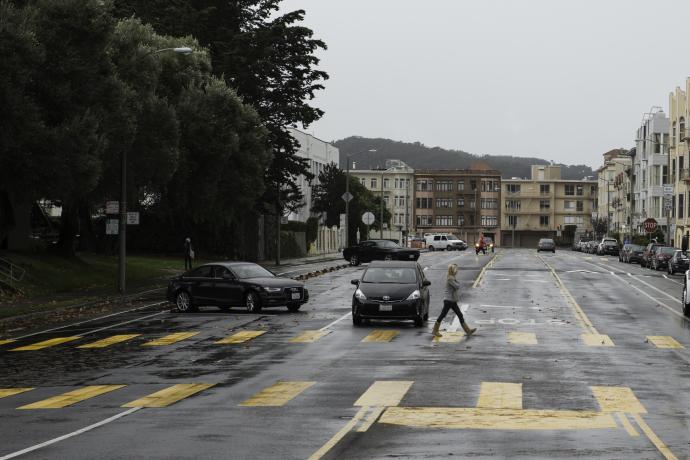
[668,78,690,246]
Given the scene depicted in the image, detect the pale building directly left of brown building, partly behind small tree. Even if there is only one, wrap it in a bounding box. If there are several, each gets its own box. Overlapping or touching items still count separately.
[350,160,414,241]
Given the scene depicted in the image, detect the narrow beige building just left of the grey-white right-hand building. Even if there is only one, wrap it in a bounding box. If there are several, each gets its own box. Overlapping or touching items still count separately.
[594,149,632,236]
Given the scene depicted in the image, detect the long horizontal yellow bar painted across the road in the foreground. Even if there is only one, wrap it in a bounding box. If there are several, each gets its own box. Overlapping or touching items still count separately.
[379,407,618,430]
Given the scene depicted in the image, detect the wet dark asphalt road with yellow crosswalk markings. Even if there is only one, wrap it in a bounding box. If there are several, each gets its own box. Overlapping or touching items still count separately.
[0,249,690,459]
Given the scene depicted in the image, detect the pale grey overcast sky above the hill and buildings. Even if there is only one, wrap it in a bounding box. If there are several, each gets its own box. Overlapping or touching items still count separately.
[283,0,690,166]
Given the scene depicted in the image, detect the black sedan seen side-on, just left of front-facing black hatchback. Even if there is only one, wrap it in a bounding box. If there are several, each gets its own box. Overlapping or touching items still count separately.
[167,262,309,313]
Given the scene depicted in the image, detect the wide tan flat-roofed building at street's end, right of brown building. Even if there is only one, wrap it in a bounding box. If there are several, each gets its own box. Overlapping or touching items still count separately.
[501,165,597,248]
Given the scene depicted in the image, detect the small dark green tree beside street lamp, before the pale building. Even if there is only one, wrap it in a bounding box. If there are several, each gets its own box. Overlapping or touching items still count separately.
[311,163,391,246]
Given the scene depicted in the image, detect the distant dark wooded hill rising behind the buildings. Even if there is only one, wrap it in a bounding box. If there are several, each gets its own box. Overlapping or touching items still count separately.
[334,136,595,180]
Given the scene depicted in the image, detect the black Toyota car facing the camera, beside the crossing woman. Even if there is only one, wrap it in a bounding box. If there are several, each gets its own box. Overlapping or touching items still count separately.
[352,261,431,327]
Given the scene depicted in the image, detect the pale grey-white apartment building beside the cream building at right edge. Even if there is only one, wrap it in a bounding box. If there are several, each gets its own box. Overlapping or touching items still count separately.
[631,107,669,234]
